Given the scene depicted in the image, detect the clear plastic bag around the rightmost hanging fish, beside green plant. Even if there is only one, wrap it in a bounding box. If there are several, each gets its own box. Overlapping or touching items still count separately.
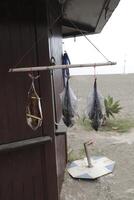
[88,78,104,131]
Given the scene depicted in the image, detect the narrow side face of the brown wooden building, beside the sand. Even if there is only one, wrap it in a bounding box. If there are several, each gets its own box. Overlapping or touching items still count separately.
[45,1,67,193]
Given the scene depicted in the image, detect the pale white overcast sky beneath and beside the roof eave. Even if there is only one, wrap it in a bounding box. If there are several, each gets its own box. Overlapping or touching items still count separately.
[63,0,134,75]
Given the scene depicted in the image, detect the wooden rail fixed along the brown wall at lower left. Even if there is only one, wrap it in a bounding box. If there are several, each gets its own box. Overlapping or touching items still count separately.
[0,136,52,152]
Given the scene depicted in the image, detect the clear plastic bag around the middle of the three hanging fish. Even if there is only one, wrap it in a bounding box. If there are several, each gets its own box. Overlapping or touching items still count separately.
[60,79,77,127]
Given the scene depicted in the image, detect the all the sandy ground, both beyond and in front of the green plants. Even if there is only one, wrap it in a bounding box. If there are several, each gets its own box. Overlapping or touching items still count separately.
[61,75,134,200]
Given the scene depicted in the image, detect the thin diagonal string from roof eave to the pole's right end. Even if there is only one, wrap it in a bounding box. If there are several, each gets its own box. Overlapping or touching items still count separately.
[69,20,111,62]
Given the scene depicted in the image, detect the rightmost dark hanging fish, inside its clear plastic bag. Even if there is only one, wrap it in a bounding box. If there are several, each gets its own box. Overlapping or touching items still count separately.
[88,79,103,131]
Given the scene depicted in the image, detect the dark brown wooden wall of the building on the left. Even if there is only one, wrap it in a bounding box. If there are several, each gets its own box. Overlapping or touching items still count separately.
[0,0,66,200]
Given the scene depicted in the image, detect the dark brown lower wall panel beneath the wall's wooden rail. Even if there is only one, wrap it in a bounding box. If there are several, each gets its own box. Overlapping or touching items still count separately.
[0,148,44,200]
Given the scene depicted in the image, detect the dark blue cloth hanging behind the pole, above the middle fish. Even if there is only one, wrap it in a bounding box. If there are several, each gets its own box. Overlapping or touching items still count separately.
[62,52,71,86]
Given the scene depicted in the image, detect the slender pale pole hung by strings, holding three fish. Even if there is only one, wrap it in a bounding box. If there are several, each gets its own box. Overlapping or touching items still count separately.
[9,61,117,72]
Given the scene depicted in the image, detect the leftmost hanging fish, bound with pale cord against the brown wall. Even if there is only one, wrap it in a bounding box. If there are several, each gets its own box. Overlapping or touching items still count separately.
[26,75,43,131]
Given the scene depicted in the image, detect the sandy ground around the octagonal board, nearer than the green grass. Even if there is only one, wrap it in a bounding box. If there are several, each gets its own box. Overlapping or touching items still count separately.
[61,126,134,200]
